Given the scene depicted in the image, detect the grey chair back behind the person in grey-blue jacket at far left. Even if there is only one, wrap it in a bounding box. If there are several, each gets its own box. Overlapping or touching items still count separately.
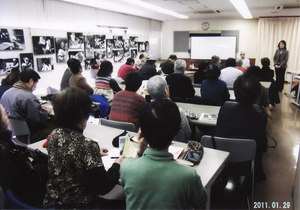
[8,117,30,144]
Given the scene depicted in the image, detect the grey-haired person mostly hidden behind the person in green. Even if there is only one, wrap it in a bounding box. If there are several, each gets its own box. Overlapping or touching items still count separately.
[147,75,191,140]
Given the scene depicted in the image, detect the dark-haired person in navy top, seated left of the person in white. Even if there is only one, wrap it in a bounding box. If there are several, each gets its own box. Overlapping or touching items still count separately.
[201,64,230,105]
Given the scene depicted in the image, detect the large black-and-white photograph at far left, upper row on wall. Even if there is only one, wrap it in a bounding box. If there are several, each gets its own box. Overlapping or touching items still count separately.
[0,28,25,50]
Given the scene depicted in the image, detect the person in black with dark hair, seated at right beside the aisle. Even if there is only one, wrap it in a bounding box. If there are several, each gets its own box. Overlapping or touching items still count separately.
[215,74,267,180]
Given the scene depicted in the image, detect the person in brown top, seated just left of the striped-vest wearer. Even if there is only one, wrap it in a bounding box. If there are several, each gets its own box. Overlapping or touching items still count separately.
[68,58,94,95]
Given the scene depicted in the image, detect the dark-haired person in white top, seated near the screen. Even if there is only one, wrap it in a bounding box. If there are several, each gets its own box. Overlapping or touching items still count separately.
[219,58,243,88]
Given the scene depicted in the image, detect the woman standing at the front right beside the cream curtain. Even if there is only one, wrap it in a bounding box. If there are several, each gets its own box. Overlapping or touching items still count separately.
[273,40,289,92]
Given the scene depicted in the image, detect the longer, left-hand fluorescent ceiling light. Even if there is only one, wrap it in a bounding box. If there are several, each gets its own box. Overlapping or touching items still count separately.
[122,0,189,19]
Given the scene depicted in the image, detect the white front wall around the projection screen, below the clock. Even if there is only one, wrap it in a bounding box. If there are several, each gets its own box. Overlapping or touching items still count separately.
[161,19,258,59]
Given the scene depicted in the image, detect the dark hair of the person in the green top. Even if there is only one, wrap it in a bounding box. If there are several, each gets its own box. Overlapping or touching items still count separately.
[139,99,181,149]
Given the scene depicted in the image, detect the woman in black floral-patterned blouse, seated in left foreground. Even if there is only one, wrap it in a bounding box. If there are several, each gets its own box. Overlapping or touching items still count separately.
[44,87,123,209]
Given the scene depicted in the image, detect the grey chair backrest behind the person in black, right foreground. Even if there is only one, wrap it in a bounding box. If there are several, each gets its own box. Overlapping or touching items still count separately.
[201,135,256,163]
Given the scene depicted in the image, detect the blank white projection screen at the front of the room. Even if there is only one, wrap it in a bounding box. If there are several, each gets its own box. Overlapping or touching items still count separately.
[191,36,236,59]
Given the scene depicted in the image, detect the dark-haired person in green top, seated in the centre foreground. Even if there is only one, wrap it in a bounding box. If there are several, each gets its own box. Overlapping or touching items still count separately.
[120,99,207,209]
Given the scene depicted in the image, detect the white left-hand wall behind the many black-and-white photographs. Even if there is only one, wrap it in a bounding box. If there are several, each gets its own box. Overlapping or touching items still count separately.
[0,0,161,91]
